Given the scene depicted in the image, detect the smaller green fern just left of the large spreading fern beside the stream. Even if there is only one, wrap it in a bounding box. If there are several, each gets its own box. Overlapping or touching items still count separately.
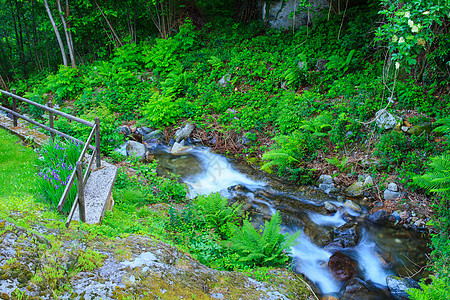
[193,193,243,237]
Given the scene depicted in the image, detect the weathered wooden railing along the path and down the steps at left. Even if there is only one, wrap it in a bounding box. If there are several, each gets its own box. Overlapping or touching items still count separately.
[0,90,101,227]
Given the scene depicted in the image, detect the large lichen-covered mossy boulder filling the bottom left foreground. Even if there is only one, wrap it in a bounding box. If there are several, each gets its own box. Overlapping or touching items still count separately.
[0,220,314,300]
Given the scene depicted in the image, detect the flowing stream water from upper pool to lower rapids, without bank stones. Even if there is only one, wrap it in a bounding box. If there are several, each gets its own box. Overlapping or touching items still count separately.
[155,147,427,299]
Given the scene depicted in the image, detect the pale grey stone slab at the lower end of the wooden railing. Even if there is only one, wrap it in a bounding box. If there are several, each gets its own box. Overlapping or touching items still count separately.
[72,161,117,224]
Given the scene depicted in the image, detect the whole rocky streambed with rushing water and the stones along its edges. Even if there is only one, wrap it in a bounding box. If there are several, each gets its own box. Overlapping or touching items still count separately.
[115,125,428,299]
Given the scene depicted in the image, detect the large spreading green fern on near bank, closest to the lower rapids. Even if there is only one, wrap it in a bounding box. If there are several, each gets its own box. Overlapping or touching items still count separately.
[229,212,300,266]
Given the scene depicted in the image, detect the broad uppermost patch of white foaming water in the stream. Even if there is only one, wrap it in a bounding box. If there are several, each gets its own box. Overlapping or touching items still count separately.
[184,148,266,198]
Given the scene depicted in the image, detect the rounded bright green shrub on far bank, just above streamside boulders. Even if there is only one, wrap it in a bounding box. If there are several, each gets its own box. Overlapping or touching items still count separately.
[140,92,181,128]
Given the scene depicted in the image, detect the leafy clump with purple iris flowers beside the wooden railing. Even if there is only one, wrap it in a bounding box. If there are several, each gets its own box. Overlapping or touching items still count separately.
[38,138,81,213]
